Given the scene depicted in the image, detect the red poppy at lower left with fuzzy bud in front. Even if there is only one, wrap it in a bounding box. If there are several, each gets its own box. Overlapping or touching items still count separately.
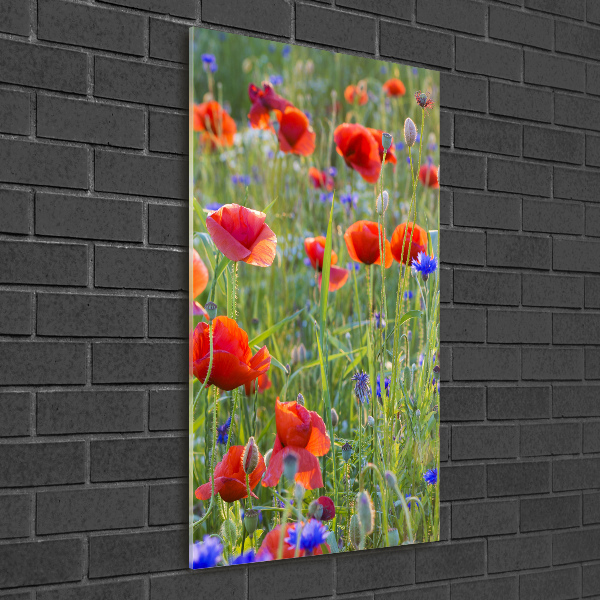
[196,446,266,502]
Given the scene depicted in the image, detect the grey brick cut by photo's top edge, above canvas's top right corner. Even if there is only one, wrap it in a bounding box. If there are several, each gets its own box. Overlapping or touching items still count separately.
[417,0,486,35]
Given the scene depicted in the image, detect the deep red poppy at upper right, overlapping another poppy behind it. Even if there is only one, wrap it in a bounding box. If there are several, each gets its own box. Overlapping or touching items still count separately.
[333,123,381,183]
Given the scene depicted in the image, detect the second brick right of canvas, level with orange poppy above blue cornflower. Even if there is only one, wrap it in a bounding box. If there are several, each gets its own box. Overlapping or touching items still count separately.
[487,232,552,270]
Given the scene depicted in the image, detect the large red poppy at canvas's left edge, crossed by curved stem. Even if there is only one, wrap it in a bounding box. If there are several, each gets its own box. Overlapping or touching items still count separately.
[192,316,271,391]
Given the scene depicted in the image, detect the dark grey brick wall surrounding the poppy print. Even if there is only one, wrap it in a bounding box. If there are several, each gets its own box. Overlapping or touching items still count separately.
[0,0,600,600]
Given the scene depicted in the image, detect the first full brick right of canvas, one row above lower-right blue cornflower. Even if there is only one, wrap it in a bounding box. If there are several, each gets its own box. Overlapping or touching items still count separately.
[452,425,519,461]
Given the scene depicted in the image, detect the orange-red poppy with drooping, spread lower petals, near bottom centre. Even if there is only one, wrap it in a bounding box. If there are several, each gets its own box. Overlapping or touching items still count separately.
[262,398,331,490]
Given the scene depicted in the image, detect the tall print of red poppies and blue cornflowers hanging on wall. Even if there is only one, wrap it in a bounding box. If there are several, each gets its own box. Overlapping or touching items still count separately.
[189,29,440,568]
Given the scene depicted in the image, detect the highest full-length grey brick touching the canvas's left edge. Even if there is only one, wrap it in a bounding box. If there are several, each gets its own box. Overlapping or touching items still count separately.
[94,56,188,108]
